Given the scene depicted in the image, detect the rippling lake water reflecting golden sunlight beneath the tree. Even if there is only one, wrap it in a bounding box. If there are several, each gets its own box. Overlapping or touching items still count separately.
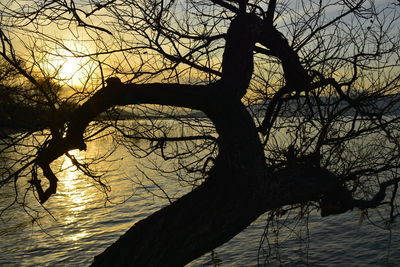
[0,129,400,266]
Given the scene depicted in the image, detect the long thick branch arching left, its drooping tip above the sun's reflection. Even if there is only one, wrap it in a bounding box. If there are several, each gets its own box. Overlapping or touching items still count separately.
[31,78,223,203]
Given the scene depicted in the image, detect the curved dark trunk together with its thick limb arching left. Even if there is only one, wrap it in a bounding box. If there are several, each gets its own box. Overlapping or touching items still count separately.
[29,76,354,266]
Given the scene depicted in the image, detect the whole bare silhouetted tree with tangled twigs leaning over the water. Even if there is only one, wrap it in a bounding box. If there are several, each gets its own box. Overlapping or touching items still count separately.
[0,0,400,266]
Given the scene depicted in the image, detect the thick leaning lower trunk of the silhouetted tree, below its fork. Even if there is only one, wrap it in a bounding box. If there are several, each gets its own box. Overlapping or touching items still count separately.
[93,100,340,266]
